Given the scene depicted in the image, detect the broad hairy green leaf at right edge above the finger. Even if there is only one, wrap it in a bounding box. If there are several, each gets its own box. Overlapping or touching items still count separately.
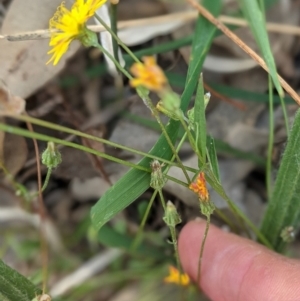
[261,110,300,252]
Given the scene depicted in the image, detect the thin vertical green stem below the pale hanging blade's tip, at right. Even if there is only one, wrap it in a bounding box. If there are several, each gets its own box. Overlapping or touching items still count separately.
[266,75,274,199]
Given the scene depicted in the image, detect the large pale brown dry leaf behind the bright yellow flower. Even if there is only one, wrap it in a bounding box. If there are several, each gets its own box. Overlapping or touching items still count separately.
[0,0,79,98]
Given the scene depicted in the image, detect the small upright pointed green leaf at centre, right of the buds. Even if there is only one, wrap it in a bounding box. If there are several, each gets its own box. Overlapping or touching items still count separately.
[194,74,206,162]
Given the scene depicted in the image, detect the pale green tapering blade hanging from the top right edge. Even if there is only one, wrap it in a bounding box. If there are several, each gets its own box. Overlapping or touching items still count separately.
[239,0,284,95]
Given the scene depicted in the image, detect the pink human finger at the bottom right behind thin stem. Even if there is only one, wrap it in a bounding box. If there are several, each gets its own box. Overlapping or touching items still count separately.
[179,219,300,301]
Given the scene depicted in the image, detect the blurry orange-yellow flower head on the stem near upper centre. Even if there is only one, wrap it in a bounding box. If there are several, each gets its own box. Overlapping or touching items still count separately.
[130,56,168,92]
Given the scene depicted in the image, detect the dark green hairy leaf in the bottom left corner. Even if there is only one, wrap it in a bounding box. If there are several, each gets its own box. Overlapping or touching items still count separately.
[0,260,42,301]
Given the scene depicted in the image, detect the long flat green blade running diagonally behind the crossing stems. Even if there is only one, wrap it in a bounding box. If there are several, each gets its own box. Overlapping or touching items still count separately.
[91,0,221,230]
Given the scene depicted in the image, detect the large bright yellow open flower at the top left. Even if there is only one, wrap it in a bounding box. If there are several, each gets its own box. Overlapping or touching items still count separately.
[47,0,106,65]
